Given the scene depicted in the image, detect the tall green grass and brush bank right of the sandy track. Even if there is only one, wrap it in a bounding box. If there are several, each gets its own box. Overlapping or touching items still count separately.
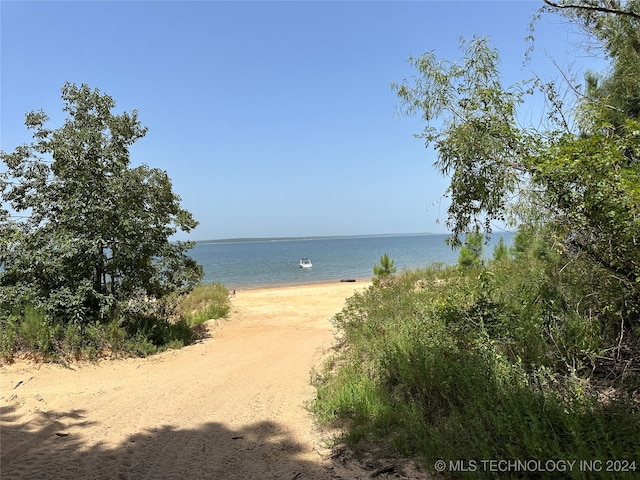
[314,258,640,478]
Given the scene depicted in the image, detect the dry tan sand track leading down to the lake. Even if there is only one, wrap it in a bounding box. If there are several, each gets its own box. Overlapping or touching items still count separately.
[0,282,430,480]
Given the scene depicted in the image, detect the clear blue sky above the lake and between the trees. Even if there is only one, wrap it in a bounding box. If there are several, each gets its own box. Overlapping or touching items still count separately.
[0,0,602,240]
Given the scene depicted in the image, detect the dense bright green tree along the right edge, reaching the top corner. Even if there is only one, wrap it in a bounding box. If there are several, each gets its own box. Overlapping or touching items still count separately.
[531,0,640,326]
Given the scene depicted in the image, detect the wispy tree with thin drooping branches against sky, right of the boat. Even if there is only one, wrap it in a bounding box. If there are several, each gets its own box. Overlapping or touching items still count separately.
[393,37,533,246]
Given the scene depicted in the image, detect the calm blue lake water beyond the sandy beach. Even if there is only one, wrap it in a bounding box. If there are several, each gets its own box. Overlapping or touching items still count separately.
[189,234,512,289]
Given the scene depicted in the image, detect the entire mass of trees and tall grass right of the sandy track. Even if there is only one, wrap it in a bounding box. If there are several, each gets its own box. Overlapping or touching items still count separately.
[314,4,640,472]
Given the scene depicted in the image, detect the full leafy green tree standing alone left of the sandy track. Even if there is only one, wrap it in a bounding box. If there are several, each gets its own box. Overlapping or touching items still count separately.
[0,83,202,323]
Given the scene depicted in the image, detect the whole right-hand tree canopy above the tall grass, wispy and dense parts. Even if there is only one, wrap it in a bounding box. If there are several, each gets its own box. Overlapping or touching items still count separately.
[394,0,640,324]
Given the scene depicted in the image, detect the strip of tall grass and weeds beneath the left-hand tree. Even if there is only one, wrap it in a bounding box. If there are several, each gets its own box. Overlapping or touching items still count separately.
[0,285,230,360]
